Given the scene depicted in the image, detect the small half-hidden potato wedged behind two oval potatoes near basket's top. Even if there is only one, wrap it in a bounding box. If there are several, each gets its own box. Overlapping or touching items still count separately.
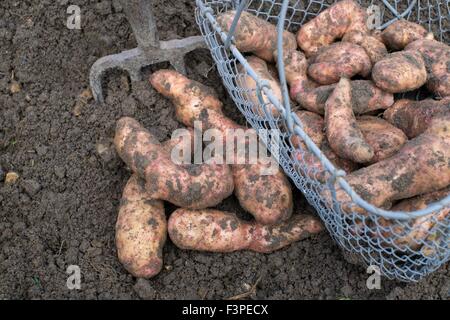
[342,30,388,65]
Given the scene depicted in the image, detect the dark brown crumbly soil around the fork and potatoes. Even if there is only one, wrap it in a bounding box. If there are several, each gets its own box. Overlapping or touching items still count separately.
[0,0,450,299]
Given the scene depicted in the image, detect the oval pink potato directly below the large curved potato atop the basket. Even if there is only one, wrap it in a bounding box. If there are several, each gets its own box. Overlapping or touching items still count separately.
[308,42,372,85]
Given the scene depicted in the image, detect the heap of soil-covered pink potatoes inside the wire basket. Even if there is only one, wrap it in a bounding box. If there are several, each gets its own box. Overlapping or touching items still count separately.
[217,0,450,250]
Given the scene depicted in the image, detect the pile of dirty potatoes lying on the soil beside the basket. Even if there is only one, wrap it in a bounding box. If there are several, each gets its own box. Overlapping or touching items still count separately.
[114,70,323,278]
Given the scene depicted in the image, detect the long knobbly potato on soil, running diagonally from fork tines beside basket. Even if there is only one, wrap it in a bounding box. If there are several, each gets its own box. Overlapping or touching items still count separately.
[150,70,293,224]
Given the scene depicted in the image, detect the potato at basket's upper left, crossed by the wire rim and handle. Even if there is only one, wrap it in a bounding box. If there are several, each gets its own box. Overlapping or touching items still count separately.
[217,10,297,62]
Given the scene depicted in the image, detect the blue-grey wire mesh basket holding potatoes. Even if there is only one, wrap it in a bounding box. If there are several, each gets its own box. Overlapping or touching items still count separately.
[196,0,450,281]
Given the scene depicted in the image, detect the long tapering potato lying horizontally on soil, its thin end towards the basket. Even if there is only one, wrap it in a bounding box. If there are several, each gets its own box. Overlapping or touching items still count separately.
[168,209,324,253]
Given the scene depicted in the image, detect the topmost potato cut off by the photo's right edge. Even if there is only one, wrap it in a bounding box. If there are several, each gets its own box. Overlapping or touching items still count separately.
[405,39,450,97]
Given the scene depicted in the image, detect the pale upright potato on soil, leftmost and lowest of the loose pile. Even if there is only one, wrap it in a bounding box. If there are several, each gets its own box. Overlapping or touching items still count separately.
[116,175,167,278]
